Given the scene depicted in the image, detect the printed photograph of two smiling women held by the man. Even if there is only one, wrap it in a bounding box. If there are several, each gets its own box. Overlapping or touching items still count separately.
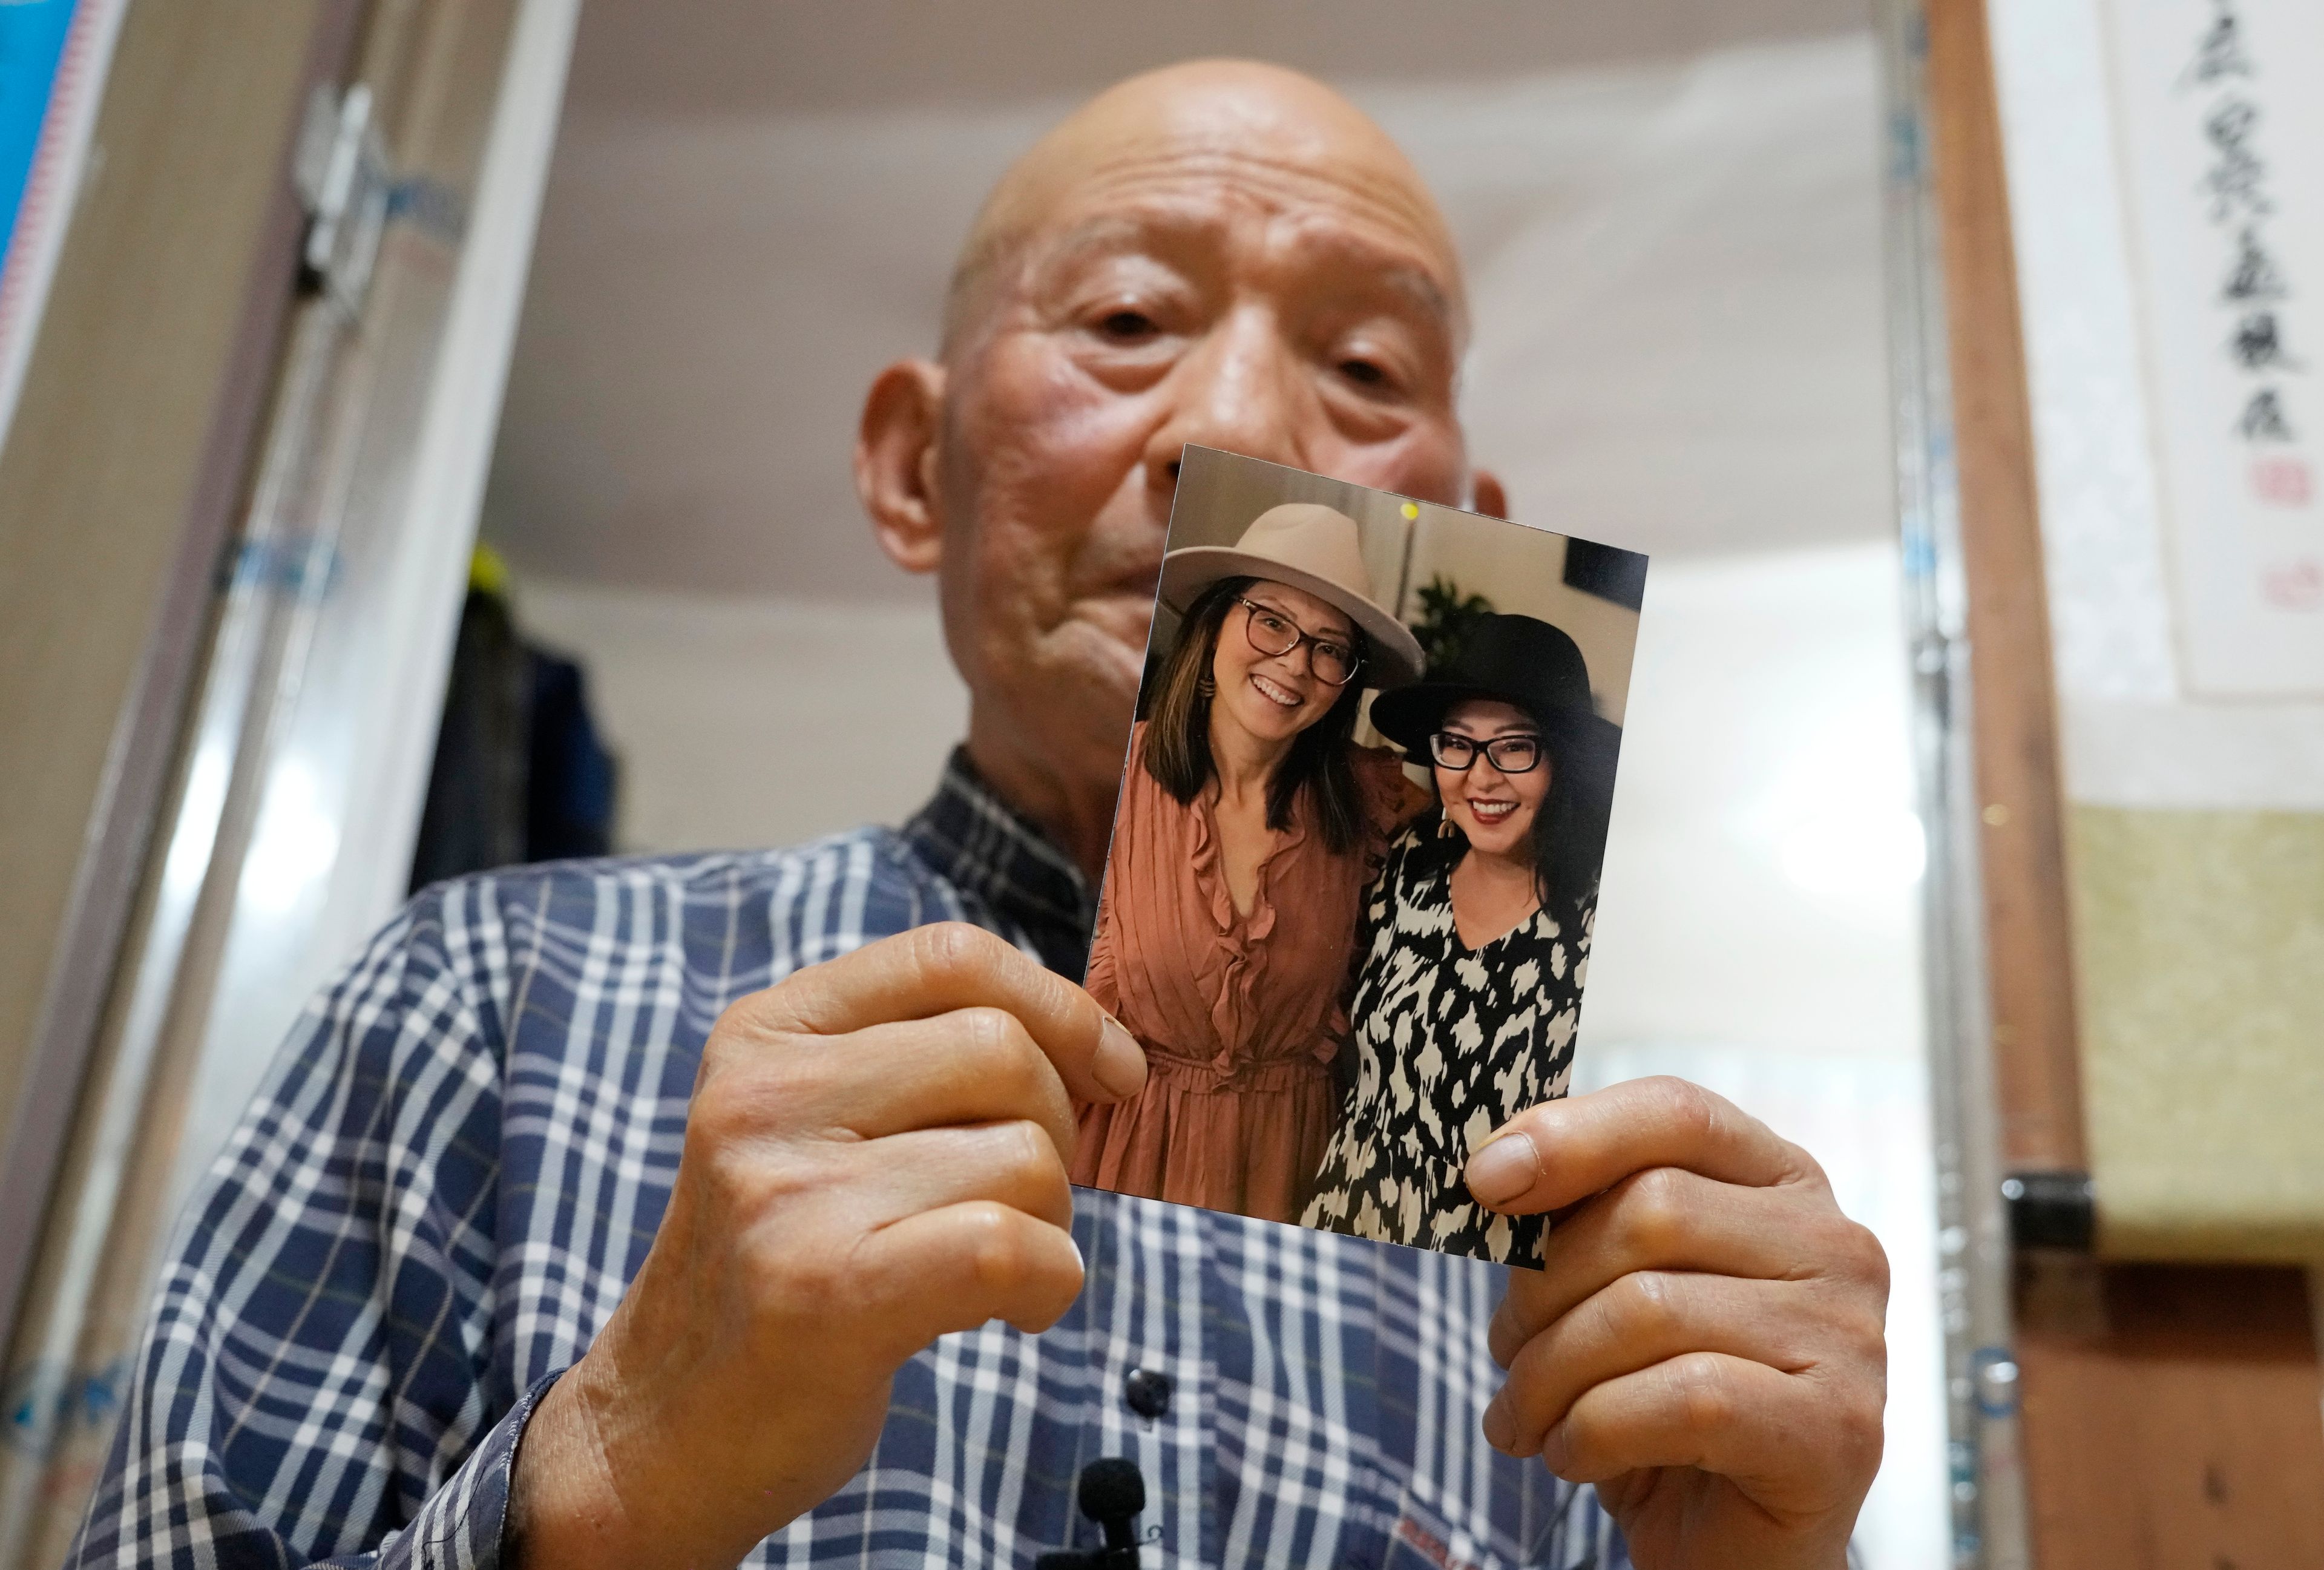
[1074,446,1646,1266]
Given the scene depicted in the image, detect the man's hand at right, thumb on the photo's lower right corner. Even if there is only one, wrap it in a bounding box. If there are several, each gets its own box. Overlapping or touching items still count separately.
[1469,1080,1887,1570]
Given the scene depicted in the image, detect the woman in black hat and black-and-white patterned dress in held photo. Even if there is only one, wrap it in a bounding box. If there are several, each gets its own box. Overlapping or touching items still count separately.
[1301,616,1620,1266]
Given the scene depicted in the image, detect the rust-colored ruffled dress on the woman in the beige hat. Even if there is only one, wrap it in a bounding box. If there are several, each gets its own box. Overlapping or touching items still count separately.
[1074,724,1427,1221]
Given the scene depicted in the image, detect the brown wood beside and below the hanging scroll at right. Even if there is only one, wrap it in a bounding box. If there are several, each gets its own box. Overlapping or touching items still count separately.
[1926,0,2324,1570]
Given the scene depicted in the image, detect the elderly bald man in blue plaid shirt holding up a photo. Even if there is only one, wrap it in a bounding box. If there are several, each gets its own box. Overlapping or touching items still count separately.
[77,63,1887,1570]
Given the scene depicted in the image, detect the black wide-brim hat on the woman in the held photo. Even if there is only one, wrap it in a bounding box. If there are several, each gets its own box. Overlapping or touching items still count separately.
[1371,616,1622,794]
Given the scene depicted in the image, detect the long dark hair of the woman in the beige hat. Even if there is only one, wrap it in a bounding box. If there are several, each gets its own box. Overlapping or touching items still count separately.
[1143,578,1364,855]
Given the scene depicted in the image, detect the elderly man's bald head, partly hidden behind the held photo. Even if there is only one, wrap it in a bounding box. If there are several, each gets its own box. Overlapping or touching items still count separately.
[855,61,1502,878]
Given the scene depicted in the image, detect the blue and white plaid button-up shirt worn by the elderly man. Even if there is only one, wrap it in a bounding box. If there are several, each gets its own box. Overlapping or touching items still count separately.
[82,755,1627,1570]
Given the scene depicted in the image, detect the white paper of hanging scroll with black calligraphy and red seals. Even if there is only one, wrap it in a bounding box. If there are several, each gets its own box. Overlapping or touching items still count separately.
[2108,0,2324,697]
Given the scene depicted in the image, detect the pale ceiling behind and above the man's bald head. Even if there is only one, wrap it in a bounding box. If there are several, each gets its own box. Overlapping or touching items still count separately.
[486,0,1892,599]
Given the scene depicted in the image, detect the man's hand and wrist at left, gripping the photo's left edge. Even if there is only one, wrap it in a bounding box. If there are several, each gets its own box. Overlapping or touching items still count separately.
[509,922,1146,1570]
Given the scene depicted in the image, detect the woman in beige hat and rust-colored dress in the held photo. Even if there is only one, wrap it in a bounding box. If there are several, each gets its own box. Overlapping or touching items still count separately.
[1074,502,1427,1221]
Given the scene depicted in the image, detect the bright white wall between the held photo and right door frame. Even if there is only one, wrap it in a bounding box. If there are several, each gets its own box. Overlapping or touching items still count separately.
[1576,544,1950,1570]
